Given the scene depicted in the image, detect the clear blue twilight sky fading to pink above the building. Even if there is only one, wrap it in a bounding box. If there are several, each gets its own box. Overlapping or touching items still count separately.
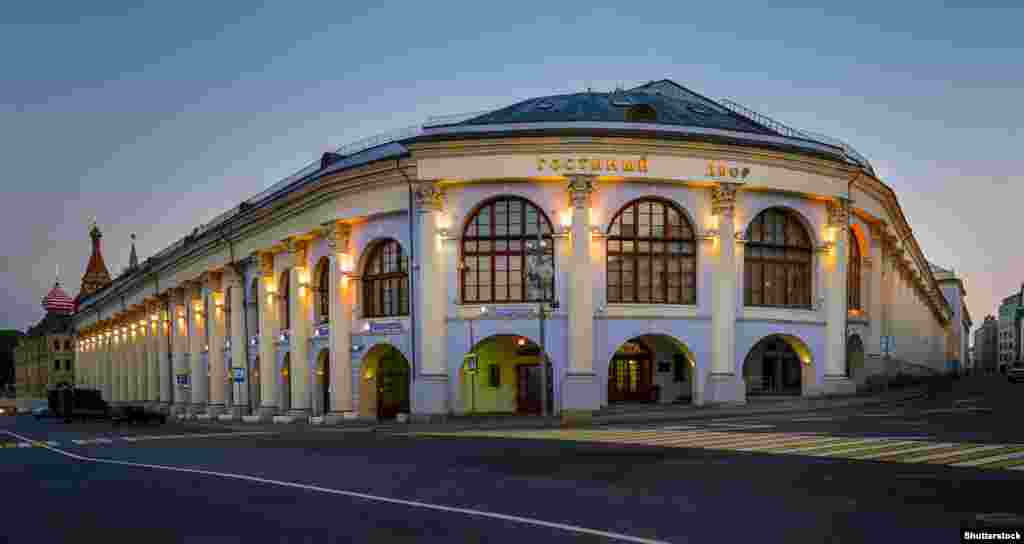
[0,0,1024,336]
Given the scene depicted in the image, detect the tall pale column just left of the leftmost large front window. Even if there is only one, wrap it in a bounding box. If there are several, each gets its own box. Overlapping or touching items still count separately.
[410,181,449,421]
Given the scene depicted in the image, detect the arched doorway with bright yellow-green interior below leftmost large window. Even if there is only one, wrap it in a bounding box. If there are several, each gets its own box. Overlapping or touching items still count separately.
[459,334,554,414]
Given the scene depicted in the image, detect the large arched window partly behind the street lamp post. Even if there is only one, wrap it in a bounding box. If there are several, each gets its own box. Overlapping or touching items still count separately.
[462,197,554,302]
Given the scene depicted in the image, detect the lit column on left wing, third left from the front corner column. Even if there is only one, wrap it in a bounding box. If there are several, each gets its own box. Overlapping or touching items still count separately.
[288,239,312,419]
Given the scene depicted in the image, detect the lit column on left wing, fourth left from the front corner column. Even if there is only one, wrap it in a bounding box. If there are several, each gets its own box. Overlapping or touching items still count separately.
[258,253,281,420]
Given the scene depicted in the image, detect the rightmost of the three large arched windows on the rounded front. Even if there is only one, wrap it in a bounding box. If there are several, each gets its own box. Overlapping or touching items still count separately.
[743,208,813,308]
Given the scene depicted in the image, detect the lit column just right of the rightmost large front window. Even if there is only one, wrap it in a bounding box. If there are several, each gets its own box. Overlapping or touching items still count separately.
[820,198,856,394]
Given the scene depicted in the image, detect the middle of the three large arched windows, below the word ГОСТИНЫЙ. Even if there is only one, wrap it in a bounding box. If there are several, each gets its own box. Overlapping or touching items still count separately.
[607,198,697,304]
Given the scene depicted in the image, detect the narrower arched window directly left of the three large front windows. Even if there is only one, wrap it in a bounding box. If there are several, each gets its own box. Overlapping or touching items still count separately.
[362,240,409,318]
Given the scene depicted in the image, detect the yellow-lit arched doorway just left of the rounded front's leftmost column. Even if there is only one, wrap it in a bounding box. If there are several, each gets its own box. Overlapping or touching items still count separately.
[359,344,410,419]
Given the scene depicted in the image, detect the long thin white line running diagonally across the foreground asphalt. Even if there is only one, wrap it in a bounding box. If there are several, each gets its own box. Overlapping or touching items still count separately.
[0,430,669,544]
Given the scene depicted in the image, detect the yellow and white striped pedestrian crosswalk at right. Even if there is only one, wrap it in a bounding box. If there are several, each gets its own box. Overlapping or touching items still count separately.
[410,425,1024,470]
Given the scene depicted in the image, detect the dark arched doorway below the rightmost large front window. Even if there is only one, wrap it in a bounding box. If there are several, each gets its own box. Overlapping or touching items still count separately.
[743,334,811,395]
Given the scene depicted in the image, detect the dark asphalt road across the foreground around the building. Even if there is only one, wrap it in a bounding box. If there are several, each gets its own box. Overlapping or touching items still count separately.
[0,379,1024,544]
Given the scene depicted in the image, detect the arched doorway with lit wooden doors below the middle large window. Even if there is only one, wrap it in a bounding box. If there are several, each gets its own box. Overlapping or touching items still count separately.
[607,334,696,404]
